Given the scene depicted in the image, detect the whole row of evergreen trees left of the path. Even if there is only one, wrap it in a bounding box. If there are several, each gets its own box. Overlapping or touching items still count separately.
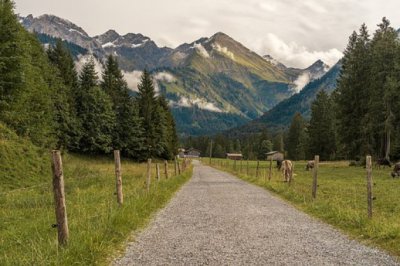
[0,0,178,160]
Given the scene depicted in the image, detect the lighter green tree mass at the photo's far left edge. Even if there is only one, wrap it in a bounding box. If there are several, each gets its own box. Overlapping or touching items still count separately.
[0,0,56,147]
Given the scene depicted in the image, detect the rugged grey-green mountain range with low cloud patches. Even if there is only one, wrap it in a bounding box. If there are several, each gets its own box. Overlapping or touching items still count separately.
[20,15,336,136]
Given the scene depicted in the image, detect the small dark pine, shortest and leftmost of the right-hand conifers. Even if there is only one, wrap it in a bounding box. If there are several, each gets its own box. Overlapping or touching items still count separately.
[286,113,307,160]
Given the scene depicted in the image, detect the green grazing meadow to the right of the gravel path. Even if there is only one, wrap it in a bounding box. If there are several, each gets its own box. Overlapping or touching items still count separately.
[203,159,400,257]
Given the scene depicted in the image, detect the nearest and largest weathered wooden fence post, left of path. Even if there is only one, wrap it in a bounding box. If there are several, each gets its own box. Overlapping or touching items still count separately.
[51,150,69,246]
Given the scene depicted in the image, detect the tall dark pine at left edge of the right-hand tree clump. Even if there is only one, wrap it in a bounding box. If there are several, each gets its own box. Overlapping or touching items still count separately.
[334,24,371,158]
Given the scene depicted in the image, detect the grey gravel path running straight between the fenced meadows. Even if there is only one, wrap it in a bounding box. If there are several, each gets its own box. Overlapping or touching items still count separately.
[114,162,400,265]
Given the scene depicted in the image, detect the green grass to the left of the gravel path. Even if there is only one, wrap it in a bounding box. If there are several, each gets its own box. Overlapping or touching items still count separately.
[0,155,191,265]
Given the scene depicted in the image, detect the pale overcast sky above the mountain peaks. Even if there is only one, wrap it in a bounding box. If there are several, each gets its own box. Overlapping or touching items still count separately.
[15,0,400,67]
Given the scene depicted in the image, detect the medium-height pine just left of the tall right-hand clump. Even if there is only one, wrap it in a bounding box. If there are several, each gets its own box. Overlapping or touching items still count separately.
[308,90,336,160]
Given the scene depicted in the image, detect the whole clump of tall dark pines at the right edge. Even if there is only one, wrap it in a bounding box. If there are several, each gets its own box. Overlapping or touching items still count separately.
[334,18,400,159]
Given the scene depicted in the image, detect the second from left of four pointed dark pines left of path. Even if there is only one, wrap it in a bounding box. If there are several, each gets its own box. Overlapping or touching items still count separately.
[78,60,115,154]
